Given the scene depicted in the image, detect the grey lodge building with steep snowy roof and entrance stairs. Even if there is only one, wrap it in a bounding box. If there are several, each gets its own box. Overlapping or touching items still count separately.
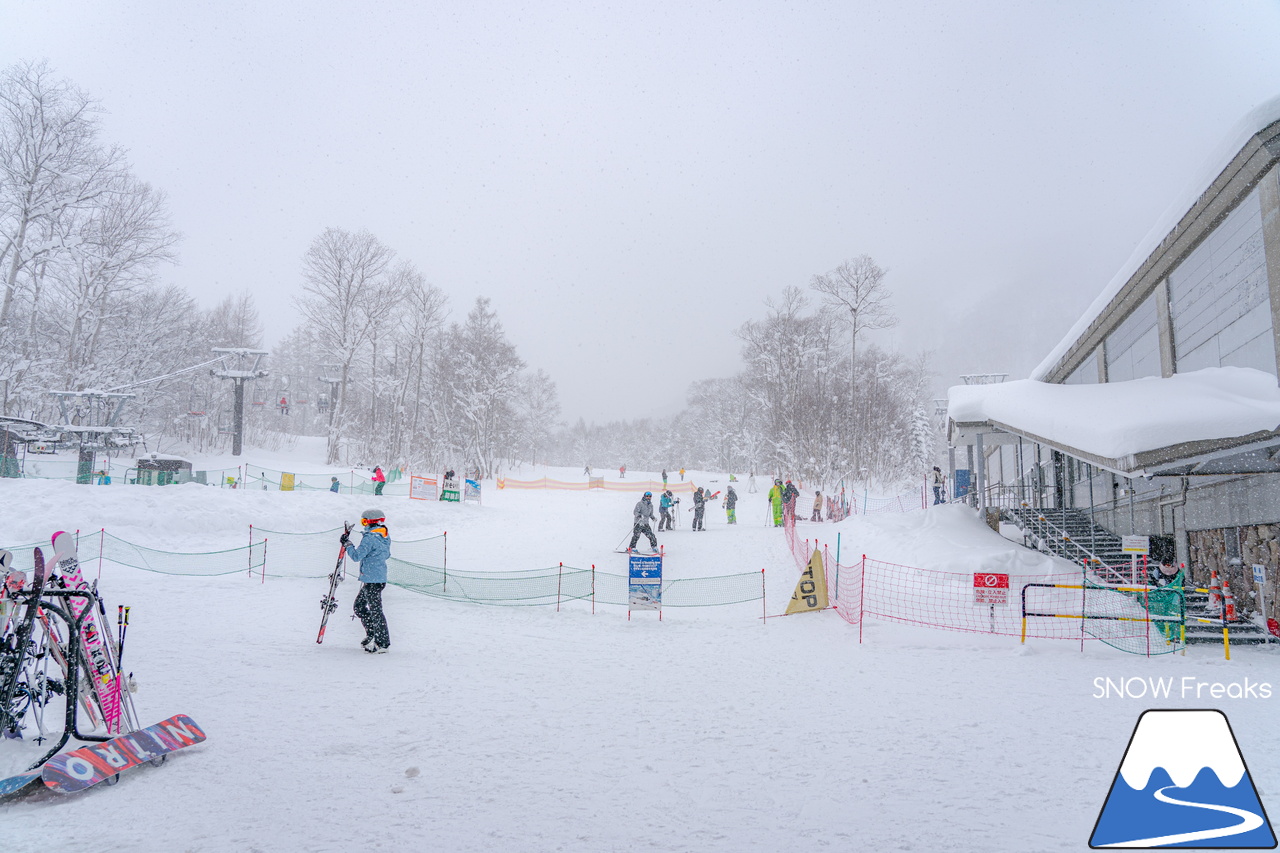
[947,97,1280,630]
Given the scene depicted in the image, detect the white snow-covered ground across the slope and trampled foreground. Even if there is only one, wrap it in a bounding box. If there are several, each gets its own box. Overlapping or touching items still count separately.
[0,448,1280,853]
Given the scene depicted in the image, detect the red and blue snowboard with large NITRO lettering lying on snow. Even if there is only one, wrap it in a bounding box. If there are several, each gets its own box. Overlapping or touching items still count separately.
[38,713,205,794]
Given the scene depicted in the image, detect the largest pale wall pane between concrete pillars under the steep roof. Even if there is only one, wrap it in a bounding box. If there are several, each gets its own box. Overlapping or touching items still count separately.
[1169,190,1276,375]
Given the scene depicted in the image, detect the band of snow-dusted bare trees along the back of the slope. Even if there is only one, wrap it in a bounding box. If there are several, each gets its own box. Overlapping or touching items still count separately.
[0,63,936,483]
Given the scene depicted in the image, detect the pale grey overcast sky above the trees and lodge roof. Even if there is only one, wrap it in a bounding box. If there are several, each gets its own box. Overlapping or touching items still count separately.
[0,0,1280,421]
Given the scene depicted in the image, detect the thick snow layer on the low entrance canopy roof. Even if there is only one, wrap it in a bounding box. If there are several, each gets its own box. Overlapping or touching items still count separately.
[947,368,1280,459]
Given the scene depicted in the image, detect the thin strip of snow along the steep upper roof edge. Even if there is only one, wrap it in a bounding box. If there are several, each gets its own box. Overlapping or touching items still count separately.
[1030,95,1280,379]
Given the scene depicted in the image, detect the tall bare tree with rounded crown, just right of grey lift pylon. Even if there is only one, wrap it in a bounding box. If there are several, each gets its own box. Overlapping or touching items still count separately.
[294,228,402,465]
